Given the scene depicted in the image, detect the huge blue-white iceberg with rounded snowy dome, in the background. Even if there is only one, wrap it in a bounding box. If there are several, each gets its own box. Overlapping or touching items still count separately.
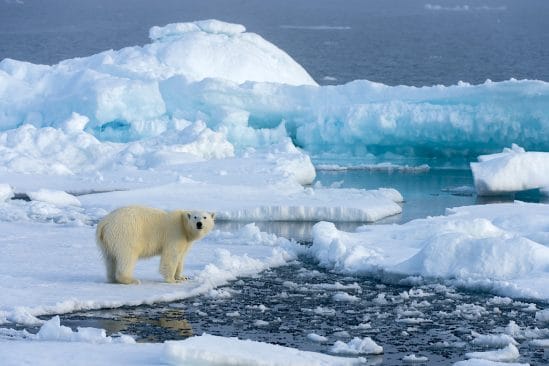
[0,20,549,158]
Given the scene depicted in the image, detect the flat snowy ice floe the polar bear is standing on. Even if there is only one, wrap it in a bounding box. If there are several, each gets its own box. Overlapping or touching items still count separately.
[0,221,299,324]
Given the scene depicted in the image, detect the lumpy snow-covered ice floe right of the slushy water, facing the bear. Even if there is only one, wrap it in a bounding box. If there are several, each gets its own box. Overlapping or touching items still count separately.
[309,202,549,300]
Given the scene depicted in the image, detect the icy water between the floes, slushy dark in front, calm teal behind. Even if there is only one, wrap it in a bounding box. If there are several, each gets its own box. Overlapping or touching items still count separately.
[31,170,549,365]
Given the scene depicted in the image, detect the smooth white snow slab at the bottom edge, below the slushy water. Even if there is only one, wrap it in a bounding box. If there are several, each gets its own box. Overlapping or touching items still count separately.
[164,334,363,366]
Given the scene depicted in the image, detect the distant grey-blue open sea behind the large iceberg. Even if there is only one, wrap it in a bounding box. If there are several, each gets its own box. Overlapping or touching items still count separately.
[0,0,549,86]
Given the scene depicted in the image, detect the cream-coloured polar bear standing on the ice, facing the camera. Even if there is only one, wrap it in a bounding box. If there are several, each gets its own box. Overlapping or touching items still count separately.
[96,206,215,284]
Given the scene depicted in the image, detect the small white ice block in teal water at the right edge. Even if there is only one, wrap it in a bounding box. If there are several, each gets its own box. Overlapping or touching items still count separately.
[471,144,549,195]
